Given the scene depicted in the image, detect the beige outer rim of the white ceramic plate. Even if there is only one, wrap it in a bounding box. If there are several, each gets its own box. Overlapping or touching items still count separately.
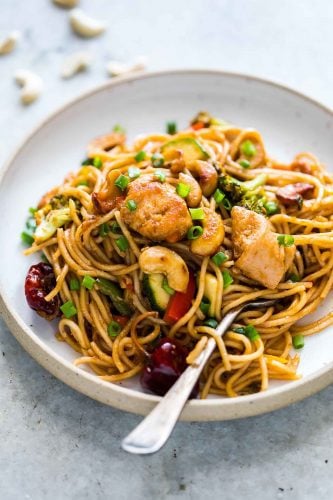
[0,68,333,421]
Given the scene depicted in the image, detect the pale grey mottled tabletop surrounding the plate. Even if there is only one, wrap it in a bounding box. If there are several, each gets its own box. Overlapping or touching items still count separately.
[0,0,333,500]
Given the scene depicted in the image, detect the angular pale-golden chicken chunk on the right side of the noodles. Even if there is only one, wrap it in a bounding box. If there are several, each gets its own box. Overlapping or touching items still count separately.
[231,207,296,288]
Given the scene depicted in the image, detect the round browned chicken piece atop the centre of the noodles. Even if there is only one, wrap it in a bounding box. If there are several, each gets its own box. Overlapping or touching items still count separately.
[120,176,192,243]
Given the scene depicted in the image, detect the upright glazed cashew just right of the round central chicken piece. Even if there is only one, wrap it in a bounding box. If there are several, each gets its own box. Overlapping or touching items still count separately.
[191,208,224,256]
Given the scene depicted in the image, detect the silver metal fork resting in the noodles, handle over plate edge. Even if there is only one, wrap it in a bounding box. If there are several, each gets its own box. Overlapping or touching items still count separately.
[121,300,276,455]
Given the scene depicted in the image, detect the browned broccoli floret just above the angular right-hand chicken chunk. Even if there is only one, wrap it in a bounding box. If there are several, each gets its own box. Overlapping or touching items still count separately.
[219,174,267,214]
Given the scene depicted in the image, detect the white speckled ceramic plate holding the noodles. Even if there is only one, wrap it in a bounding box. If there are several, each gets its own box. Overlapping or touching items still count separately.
[0,71,333,420]
